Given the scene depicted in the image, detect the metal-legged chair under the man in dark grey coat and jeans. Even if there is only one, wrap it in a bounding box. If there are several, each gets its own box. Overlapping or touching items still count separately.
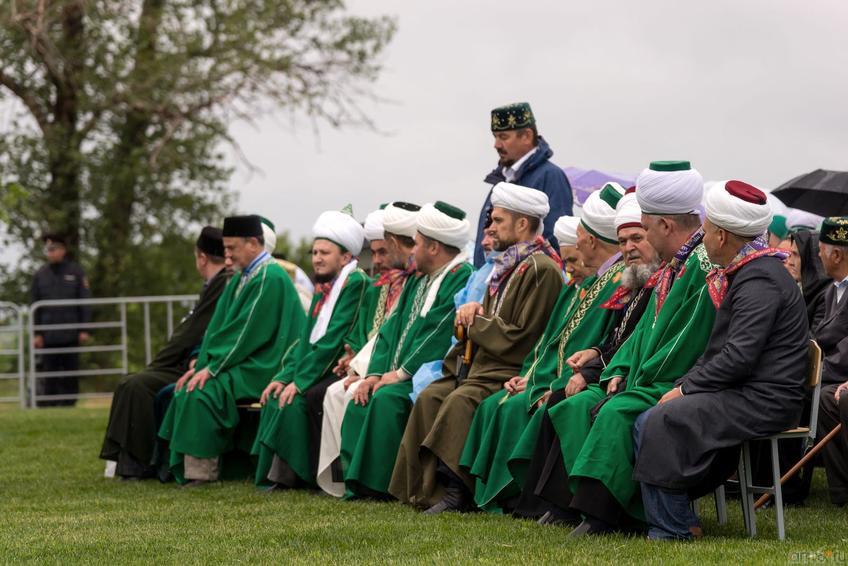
[715,340,822,540]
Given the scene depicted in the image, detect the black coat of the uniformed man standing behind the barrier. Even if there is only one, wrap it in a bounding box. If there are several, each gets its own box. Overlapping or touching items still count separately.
[31,259,91,347]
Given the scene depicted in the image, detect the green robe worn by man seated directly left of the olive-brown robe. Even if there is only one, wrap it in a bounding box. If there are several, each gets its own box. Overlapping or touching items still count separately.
[341,263,473,497]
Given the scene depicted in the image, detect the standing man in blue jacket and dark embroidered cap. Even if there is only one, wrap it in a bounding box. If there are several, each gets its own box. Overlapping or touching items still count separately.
[474,102,572,269]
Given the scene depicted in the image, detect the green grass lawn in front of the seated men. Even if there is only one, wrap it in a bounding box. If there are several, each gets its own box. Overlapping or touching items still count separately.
[0,407,848,566]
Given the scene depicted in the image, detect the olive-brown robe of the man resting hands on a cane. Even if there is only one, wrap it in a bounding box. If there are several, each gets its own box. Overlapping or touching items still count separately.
[389,253,563,507]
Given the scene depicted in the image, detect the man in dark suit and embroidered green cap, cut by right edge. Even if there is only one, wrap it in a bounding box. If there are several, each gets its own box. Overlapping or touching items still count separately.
[814,220,848,507]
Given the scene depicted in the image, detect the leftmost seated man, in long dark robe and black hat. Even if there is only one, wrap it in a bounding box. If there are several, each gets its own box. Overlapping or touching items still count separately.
[100,226,233,479]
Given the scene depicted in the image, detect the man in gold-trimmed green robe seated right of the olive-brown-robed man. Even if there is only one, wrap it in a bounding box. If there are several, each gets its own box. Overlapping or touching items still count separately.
[460,183,624,511]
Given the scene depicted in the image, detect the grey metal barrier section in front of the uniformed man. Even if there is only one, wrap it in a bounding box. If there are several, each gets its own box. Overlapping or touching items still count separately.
[25,295,198,407]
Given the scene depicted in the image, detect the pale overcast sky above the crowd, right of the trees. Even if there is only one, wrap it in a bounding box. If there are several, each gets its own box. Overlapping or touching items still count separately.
[232,0,848,241]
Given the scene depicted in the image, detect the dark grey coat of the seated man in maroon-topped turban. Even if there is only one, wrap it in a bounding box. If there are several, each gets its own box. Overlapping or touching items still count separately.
[634,257,809,492]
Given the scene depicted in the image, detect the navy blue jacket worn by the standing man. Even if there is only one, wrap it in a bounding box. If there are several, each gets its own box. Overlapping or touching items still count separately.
[474,136,573,268]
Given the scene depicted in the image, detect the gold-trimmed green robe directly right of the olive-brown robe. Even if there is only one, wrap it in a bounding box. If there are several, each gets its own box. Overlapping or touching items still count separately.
[460,261,624,511]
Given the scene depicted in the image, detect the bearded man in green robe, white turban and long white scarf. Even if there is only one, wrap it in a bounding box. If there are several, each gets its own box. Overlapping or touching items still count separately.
[252,206,370,490]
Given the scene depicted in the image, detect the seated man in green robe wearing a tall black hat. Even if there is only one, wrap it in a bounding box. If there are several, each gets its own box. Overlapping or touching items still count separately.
[159,215,304,486]
